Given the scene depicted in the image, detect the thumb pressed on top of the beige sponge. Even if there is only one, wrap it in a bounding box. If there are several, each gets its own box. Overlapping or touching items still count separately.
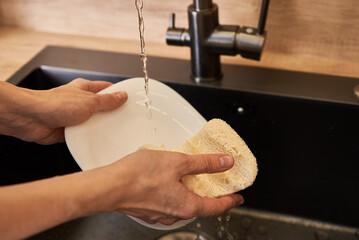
[181,154,234,177]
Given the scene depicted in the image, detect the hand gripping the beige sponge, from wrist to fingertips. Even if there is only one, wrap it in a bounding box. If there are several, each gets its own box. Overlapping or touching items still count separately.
[84,150,243,224]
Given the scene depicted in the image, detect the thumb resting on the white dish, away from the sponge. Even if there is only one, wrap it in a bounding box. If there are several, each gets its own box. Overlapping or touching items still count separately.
[96,92,128,111]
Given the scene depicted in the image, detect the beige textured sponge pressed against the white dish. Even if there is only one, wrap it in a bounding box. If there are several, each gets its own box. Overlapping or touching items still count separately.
[143,119,258,197]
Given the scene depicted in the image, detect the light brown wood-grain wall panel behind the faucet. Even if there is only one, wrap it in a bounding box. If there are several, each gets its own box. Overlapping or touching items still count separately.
[0,0,359,75]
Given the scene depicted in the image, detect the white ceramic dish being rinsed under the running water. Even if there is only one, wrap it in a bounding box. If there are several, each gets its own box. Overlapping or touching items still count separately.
[65,78,206,230]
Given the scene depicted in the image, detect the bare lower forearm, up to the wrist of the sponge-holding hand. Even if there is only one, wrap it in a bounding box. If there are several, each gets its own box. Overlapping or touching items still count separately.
[0,166,126,239]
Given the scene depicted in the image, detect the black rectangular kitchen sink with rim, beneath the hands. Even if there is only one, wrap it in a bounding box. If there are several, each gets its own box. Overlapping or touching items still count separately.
[0,47,359,239]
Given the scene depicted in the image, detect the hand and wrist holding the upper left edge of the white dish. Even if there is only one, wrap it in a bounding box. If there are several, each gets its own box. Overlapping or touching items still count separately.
[0,79,127,144]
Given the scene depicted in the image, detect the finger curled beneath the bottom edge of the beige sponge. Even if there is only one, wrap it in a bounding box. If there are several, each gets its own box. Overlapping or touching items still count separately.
[194,194,244,217]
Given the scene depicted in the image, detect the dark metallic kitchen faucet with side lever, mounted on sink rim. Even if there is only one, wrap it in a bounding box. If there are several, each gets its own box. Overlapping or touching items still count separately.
[166,0,269,82]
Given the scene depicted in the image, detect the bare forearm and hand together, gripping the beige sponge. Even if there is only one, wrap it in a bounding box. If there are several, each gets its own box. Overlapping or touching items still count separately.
[0,150,243,239]
